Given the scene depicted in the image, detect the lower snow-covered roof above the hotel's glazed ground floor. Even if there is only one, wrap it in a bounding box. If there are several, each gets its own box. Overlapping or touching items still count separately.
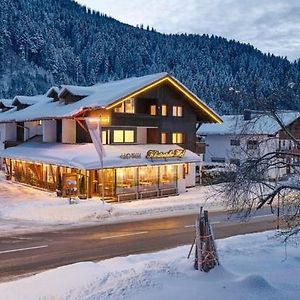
[0,142,201,170]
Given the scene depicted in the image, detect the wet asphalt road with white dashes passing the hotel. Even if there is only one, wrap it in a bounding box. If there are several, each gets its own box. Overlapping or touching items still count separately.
[0,211,276,281]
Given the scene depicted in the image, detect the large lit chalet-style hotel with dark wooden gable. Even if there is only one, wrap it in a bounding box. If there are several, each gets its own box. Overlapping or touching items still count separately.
[0,73,222,199]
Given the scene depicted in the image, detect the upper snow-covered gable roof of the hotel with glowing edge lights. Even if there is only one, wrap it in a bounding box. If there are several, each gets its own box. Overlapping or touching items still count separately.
[0,73,222,123]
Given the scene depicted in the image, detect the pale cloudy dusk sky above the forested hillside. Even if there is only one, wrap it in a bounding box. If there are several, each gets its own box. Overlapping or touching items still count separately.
[77,0,300,60]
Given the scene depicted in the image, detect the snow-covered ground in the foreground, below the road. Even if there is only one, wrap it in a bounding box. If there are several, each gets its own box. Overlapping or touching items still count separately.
[0,232,300,300]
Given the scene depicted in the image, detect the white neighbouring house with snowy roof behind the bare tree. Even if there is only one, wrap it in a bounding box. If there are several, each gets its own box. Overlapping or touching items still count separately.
[197,111,300,177]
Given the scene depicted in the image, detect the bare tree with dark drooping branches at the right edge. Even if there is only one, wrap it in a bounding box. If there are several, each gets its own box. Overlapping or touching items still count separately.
[219,83,300,240]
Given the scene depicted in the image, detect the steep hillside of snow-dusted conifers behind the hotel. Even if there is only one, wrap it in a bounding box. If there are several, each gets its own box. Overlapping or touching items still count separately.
[0,0,300,113]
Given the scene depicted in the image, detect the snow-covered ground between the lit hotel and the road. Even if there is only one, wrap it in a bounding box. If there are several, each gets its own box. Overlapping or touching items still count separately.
[0,176,222,236]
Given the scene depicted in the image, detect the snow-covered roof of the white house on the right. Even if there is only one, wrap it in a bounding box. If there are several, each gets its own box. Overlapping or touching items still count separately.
[197,111,300,136]
